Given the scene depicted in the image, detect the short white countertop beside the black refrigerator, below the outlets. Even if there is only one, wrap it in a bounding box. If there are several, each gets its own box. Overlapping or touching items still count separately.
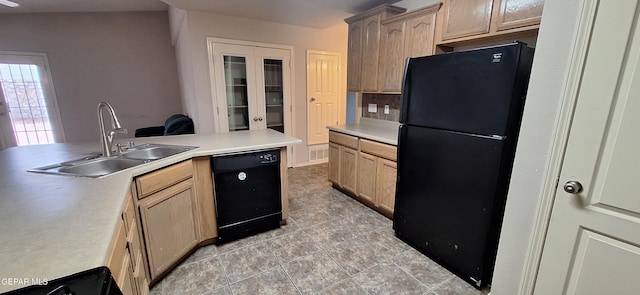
[327,118,400,146]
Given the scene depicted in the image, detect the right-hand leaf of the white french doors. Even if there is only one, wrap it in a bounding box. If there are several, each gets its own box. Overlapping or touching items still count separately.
[250,47,291,133]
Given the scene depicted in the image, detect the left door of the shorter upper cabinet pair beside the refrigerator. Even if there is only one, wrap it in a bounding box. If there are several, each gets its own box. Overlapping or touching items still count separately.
[379,21,408,92]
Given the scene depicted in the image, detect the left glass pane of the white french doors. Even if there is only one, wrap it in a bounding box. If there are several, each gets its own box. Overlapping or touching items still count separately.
[224,55,249,131]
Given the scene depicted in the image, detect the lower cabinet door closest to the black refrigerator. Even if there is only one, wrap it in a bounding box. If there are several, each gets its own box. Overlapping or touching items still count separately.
[376,158,398,216]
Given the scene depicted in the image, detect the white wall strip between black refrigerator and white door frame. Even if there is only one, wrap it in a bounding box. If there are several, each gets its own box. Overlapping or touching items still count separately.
[491,0,580,295]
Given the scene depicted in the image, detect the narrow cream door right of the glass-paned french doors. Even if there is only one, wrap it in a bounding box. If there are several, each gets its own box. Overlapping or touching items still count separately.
[307,50,340,145]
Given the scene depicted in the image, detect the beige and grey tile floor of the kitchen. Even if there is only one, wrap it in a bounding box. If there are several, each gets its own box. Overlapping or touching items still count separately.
[151,164,488,295]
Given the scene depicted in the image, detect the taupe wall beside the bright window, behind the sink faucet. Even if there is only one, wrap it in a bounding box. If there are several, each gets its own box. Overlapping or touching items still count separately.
[0,11,182,142]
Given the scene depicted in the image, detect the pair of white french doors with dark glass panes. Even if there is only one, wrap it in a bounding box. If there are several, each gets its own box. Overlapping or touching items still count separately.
[210,43,291,134]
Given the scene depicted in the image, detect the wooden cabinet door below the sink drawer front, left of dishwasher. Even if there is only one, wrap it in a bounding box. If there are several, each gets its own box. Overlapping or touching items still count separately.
[139,179,198,280]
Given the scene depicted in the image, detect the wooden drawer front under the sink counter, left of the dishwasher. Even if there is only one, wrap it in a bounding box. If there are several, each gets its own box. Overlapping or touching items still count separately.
[136,160,193,199]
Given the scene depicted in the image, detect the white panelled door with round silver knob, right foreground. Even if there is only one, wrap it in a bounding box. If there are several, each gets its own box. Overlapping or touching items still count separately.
[534,0,640,295]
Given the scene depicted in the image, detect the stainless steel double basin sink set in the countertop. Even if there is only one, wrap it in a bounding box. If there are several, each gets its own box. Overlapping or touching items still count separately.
[29,144,197,178]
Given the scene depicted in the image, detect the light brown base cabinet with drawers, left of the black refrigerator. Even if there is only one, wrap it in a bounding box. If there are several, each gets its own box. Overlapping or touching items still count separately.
[329,131,397,218]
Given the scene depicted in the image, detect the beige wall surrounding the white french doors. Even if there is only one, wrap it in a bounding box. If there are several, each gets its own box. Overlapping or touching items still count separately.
[171,10,347,165]
